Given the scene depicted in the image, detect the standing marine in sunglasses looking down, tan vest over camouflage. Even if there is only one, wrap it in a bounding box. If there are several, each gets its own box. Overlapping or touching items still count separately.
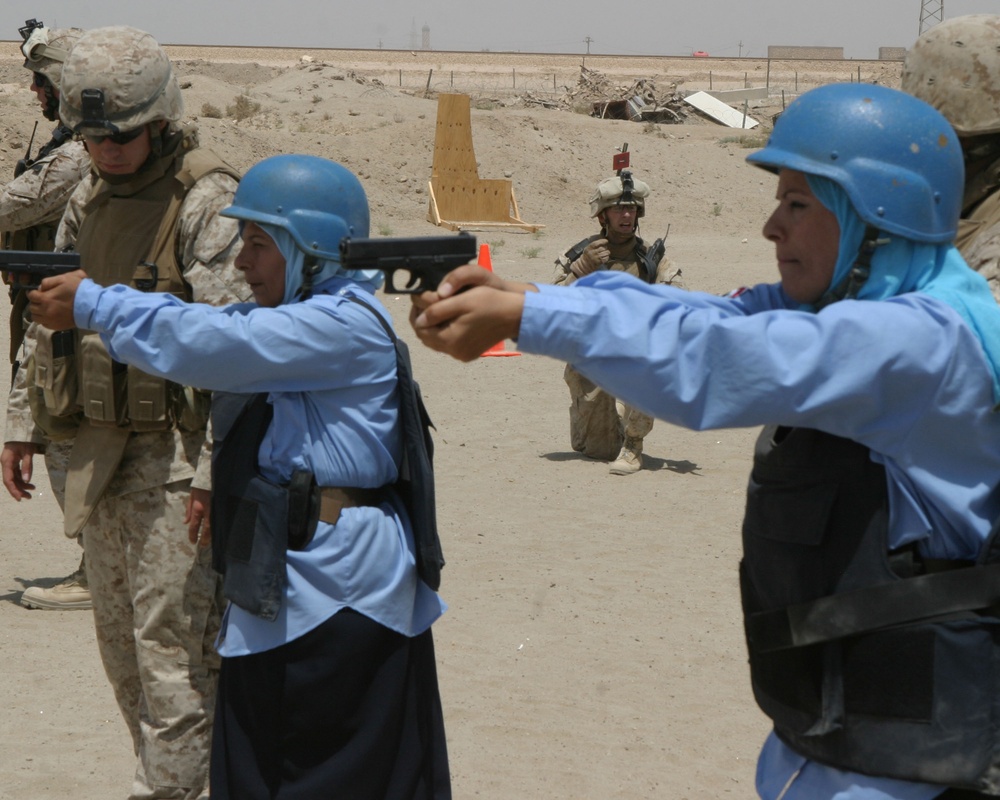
[5,27,249,798]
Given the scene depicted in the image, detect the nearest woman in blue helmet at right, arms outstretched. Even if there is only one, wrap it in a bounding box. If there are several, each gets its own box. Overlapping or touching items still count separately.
[411,84,1000,800]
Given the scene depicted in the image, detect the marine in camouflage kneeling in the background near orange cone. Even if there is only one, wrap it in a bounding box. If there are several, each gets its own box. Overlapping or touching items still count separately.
[554,170,680,475]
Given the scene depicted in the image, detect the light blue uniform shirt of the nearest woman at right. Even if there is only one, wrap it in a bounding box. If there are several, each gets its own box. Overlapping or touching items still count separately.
[518,272,1000,800]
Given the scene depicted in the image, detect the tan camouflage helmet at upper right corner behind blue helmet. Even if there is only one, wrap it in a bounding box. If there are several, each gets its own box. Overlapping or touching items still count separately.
[903,14,1000,136]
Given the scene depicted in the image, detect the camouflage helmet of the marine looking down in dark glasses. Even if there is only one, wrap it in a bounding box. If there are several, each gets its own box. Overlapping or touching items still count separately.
[59,25,184,135]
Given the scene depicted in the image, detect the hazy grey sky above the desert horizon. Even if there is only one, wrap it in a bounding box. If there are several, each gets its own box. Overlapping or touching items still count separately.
[11,0,1000,58]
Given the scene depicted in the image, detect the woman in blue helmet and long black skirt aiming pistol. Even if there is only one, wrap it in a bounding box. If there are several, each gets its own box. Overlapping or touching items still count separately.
[34,155,451,800]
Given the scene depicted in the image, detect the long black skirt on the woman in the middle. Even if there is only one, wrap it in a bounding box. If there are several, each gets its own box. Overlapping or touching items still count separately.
[211,610,451,800]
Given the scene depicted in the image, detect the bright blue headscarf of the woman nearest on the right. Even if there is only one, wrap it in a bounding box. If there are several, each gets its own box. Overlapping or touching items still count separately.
[802,173,1000,403]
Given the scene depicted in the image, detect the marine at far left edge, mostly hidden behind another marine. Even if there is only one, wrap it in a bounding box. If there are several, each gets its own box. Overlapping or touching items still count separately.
[0,20,90,610]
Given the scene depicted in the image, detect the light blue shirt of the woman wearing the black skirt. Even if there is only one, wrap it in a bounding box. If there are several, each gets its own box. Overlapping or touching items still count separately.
[74,277,445,656]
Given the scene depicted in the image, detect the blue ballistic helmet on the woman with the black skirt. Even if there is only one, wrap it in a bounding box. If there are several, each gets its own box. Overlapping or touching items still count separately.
[221,155,370,262]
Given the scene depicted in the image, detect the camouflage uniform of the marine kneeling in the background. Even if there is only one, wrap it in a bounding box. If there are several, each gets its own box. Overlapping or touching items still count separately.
[553,234,680,461]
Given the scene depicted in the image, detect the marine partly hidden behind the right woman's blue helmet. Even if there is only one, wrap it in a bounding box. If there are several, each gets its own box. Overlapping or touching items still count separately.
[903,14,1000,302]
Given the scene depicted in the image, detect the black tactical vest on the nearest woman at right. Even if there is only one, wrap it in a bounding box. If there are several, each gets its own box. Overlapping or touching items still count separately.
[740,427,1000,794]
